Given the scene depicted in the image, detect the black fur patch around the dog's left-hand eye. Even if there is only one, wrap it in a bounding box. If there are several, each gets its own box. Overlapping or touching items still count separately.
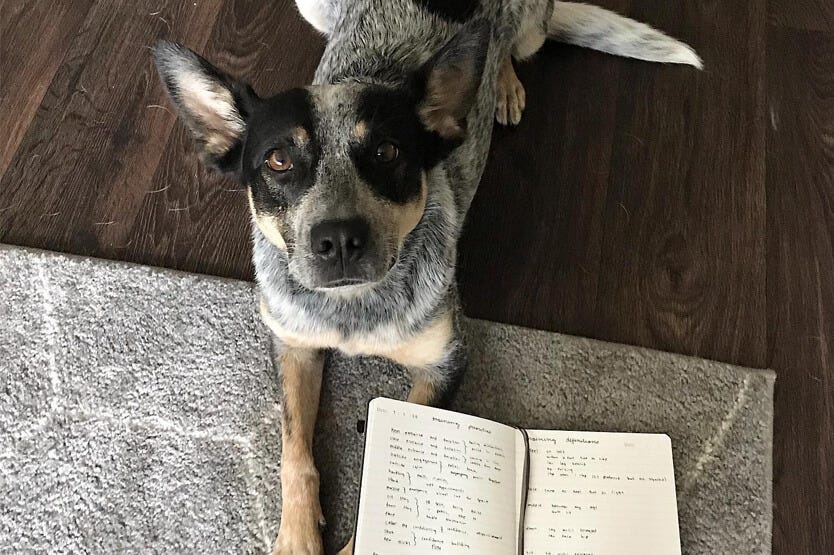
[242,89,319,212]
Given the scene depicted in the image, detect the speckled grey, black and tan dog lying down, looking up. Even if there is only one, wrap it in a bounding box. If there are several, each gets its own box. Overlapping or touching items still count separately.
[154,0,701,555]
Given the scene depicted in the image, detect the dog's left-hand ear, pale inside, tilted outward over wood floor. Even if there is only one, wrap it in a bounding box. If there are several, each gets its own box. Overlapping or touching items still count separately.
[153,41,258,173]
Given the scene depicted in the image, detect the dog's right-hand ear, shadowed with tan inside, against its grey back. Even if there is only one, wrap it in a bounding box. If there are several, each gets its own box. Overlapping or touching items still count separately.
[418,19,490,140]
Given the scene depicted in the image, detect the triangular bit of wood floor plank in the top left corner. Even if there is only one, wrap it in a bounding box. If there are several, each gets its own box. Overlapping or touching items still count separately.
[0,0,92,178]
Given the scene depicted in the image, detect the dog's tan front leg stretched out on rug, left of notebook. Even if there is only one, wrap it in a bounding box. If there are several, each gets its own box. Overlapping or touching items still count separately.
[272,338,324,555]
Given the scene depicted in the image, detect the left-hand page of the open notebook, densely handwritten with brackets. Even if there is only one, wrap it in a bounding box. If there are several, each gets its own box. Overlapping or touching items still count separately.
[355,398,520,555]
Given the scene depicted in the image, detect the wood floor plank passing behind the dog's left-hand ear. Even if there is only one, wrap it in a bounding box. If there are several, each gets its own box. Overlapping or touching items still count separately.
[123,0,324,279]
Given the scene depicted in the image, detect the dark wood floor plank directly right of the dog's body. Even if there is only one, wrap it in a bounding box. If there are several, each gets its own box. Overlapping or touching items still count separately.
[458,44,622,335]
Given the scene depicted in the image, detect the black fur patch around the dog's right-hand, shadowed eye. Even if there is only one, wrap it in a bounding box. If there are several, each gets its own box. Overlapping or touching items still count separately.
[351,86,451,203]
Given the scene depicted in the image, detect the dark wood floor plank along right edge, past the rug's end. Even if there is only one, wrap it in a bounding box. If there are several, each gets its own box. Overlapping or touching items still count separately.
[767,23,834,555]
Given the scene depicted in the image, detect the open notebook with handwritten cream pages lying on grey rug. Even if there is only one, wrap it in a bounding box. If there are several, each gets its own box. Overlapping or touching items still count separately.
[355,398,680,555]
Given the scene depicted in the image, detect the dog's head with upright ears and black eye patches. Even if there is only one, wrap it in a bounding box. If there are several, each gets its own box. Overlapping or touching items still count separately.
[154,23,489,289]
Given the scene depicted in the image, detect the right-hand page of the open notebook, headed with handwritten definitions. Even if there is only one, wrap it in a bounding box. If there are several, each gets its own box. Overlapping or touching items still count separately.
[524,430,680,555]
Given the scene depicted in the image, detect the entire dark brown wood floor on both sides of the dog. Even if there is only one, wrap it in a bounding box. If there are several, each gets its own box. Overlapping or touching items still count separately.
[0,0,834,555]
